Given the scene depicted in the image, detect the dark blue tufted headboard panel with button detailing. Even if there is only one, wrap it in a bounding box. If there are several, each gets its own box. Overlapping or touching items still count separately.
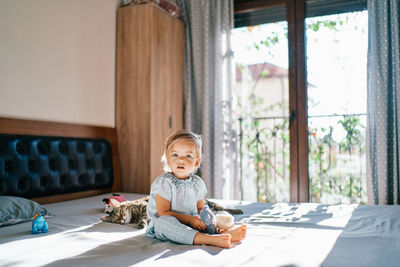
[0,134,114,198]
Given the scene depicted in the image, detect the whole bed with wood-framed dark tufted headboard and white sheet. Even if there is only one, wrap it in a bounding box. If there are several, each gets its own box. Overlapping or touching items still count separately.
[0,119,400,267]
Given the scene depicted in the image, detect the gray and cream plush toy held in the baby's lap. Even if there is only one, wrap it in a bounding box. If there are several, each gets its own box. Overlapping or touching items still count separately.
[200,205,234,234]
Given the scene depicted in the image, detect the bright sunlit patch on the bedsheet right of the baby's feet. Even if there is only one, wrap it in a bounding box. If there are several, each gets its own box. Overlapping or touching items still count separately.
[233,203,358,266]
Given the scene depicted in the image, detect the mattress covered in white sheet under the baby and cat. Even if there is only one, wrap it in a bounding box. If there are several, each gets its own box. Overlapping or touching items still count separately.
[0,193,400,267]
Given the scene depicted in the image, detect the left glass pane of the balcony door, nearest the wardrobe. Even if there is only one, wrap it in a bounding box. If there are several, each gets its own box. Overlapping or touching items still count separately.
[232,3,290,202]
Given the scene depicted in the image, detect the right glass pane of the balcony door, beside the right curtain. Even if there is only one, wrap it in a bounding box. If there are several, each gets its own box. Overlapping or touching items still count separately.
[305,8,368,204]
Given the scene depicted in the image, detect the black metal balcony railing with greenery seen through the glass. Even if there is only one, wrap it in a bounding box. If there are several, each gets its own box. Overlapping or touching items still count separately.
[238,114,366,204]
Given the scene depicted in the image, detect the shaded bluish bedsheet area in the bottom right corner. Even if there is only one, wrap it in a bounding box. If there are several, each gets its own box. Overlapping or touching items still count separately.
[322,205,400,267]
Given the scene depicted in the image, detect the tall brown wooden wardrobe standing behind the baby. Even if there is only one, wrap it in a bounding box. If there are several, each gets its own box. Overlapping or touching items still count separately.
[116,2,184,194]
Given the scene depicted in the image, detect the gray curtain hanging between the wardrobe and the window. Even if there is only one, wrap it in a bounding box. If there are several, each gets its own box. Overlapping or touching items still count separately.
[177,0,239,198]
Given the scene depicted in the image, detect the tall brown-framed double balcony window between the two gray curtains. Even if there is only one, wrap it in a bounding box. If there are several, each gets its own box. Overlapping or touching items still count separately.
[233,0,367,203]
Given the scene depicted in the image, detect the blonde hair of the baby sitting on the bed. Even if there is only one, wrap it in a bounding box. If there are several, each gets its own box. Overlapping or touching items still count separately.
[161,129,203,172]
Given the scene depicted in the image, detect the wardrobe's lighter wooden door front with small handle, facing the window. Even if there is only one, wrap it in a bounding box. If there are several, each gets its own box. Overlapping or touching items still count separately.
[151,4,184,184]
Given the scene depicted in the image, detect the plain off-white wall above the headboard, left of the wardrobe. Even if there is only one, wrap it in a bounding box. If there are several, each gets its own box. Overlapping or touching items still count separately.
[0,0,120,127]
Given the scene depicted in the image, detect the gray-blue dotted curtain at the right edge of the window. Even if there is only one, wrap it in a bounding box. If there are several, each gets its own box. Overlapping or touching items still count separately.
[367,0,400,204]
